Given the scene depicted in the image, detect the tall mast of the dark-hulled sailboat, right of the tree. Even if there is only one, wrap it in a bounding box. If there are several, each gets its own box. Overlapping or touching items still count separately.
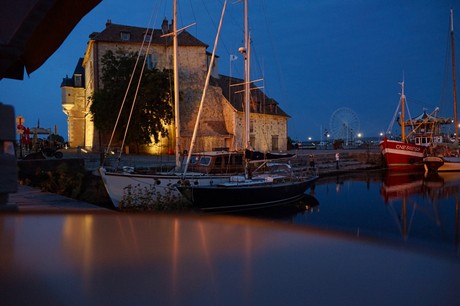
[244,0,251,148]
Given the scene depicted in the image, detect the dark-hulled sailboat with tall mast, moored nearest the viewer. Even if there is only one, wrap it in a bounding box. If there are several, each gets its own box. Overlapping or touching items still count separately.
[177,0,318,211]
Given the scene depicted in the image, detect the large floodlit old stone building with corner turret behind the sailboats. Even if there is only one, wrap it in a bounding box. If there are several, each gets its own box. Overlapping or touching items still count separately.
[61,19,289,154]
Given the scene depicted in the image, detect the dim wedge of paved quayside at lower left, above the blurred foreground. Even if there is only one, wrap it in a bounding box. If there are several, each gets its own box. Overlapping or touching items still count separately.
[0,185,116,213]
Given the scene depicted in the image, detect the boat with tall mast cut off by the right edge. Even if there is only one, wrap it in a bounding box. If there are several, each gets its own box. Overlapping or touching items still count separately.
[423,9,460,172]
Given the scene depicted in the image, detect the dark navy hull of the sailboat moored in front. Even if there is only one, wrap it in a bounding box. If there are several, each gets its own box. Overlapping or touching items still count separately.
[178,176,318,212]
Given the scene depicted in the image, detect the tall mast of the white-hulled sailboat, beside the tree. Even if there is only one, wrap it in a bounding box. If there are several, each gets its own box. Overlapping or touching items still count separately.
[172,0,180,169]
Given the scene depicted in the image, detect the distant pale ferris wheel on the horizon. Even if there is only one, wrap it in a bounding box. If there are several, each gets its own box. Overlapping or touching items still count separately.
[329,107,360,144]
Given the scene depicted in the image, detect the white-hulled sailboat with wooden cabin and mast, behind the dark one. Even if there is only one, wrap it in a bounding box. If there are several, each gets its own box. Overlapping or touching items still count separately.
[99,0,239,208]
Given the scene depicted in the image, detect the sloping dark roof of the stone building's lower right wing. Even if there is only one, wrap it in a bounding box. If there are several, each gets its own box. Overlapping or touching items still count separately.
[210,75,290,117]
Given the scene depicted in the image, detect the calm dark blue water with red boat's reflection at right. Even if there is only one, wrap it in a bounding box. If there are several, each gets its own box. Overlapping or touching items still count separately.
[232,171,460,259]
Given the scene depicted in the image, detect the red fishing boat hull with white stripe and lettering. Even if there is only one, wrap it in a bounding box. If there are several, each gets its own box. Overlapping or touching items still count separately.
[380,138,425,170]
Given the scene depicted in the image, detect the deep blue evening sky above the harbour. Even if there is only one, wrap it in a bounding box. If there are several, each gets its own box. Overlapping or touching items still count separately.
[0,0,460,140]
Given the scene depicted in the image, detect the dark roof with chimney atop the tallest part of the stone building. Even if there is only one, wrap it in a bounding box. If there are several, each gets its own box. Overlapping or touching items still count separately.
[89,20,208,48]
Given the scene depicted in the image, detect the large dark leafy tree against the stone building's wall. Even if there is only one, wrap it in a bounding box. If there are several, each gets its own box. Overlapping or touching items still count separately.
[89,49,173,150]
